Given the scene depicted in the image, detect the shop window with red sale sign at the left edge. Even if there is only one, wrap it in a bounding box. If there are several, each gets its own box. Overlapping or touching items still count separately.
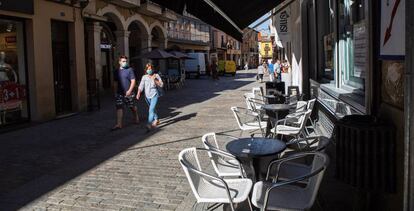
[0,18,29,128]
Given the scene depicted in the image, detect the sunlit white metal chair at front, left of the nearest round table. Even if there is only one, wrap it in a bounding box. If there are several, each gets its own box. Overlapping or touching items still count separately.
[178,147,253,211]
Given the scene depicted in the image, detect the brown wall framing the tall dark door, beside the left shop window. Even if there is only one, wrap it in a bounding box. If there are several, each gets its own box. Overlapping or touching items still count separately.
[0,0,86,121]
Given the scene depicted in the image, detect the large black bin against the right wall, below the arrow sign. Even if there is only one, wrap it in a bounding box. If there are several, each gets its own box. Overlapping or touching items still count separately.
[335,115,396,193]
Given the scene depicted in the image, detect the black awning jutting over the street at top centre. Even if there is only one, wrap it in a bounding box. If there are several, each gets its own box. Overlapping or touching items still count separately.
[152,0,284,41]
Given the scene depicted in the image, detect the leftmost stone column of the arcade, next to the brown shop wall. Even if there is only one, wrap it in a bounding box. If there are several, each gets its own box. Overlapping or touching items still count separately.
[86,22,102,84]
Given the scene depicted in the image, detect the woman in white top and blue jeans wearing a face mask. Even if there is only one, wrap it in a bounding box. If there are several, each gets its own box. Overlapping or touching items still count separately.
[137,63,164,130]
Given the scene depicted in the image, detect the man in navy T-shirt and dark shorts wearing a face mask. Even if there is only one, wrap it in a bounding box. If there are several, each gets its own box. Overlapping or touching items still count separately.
[112,56,139,130]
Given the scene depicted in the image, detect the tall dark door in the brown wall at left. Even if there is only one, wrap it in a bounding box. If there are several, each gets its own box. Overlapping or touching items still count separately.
[51,21,72,115]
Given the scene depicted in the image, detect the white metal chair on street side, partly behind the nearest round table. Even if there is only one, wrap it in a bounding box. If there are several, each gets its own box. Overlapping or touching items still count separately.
[201,133,244,177]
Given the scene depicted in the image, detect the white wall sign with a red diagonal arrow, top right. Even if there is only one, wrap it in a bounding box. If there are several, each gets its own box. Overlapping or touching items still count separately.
[379,0,405,59]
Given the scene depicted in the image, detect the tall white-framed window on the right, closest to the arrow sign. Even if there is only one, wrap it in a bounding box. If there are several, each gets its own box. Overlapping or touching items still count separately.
[338,0,368,90]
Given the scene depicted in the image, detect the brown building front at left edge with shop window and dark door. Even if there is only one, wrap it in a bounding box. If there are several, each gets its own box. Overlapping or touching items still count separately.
[0,0,87,128]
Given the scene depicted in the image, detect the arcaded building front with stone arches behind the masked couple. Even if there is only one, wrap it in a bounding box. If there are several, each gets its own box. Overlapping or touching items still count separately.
[84,0,176,90]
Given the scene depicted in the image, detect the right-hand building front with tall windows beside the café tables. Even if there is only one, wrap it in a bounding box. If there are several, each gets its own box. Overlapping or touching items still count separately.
[296,0,406,210]
